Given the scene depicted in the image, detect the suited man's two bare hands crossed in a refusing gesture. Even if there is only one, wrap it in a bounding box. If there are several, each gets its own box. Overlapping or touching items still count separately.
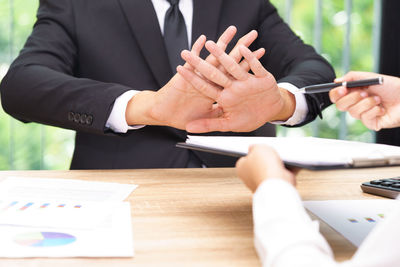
[125,26,295,133]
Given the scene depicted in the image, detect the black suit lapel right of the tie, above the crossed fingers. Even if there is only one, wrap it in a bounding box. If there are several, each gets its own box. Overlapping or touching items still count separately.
[192,0,223,58]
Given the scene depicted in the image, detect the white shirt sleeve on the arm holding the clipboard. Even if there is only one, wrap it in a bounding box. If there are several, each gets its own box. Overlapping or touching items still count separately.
[253,179,335,267]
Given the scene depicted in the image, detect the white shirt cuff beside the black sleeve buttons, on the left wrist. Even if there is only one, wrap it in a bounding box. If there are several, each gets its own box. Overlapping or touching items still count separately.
[106,90,145,133]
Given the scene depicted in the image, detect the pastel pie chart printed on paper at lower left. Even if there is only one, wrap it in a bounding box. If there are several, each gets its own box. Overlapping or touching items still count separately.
[14,232,76,247]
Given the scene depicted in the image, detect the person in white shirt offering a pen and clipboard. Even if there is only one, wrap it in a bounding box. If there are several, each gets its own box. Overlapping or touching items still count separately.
[236,72,400,267]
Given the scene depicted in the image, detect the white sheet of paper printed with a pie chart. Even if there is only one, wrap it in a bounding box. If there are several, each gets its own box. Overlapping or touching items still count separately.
[0,202,134,258]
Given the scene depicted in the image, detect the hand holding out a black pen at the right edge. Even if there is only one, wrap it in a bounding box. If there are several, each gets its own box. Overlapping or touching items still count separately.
[329,71,400,131]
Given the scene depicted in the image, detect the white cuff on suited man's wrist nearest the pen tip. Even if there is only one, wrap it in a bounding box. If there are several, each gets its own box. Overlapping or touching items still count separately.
[271,83,308,126]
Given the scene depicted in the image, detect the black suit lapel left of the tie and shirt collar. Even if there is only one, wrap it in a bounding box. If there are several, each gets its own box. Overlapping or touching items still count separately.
[119,0,172,87]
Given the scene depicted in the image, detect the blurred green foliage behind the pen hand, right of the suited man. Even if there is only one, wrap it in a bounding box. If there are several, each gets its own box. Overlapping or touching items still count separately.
[271,0,375,142]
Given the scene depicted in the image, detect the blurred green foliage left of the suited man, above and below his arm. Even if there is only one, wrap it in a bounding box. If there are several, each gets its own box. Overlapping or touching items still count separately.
[0,0,74,170]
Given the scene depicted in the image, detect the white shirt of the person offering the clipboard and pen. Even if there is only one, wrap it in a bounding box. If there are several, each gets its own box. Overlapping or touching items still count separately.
[253,179,400,267]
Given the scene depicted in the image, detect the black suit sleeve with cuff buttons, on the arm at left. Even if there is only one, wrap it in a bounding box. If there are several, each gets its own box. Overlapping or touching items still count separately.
[0,64,130,134]
